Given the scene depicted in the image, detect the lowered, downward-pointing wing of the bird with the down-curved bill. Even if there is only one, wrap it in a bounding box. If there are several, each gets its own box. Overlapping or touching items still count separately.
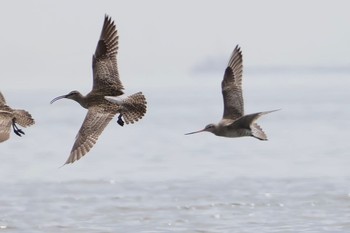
[65,107,115,164]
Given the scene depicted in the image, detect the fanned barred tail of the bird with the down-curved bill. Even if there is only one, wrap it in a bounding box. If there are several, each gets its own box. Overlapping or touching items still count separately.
[122,92,147,124]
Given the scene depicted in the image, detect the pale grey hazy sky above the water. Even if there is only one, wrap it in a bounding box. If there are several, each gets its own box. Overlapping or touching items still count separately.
[0,0,350,92]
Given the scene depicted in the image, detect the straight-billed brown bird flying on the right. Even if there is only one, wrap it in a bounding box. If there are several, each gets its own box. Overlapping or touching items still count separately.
[186,45,278,140]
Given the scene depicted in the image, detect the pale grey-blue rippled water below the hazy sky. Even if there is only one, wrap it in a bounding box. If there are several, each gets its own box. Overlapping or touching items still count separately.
[0,73,350,233]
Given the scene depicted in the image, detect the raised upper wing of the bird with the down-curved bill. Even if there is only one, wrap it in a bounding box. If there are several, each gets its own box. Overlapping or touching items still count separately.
[92,15,124,96]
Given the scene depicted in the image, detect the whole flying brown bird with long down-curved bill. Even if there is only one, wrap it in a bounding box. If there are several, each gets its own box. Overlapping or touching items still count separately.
[51,15,147,164]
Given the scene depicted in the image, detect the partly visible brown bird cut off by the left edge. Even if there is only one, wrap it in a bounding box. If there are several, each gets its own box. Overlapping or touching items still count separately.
[0,92,35,142]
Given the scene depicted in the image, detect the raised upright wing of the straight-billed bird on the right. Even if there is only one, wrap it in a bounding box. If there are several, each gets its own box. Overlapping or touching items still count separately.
[221,45,244,120]
